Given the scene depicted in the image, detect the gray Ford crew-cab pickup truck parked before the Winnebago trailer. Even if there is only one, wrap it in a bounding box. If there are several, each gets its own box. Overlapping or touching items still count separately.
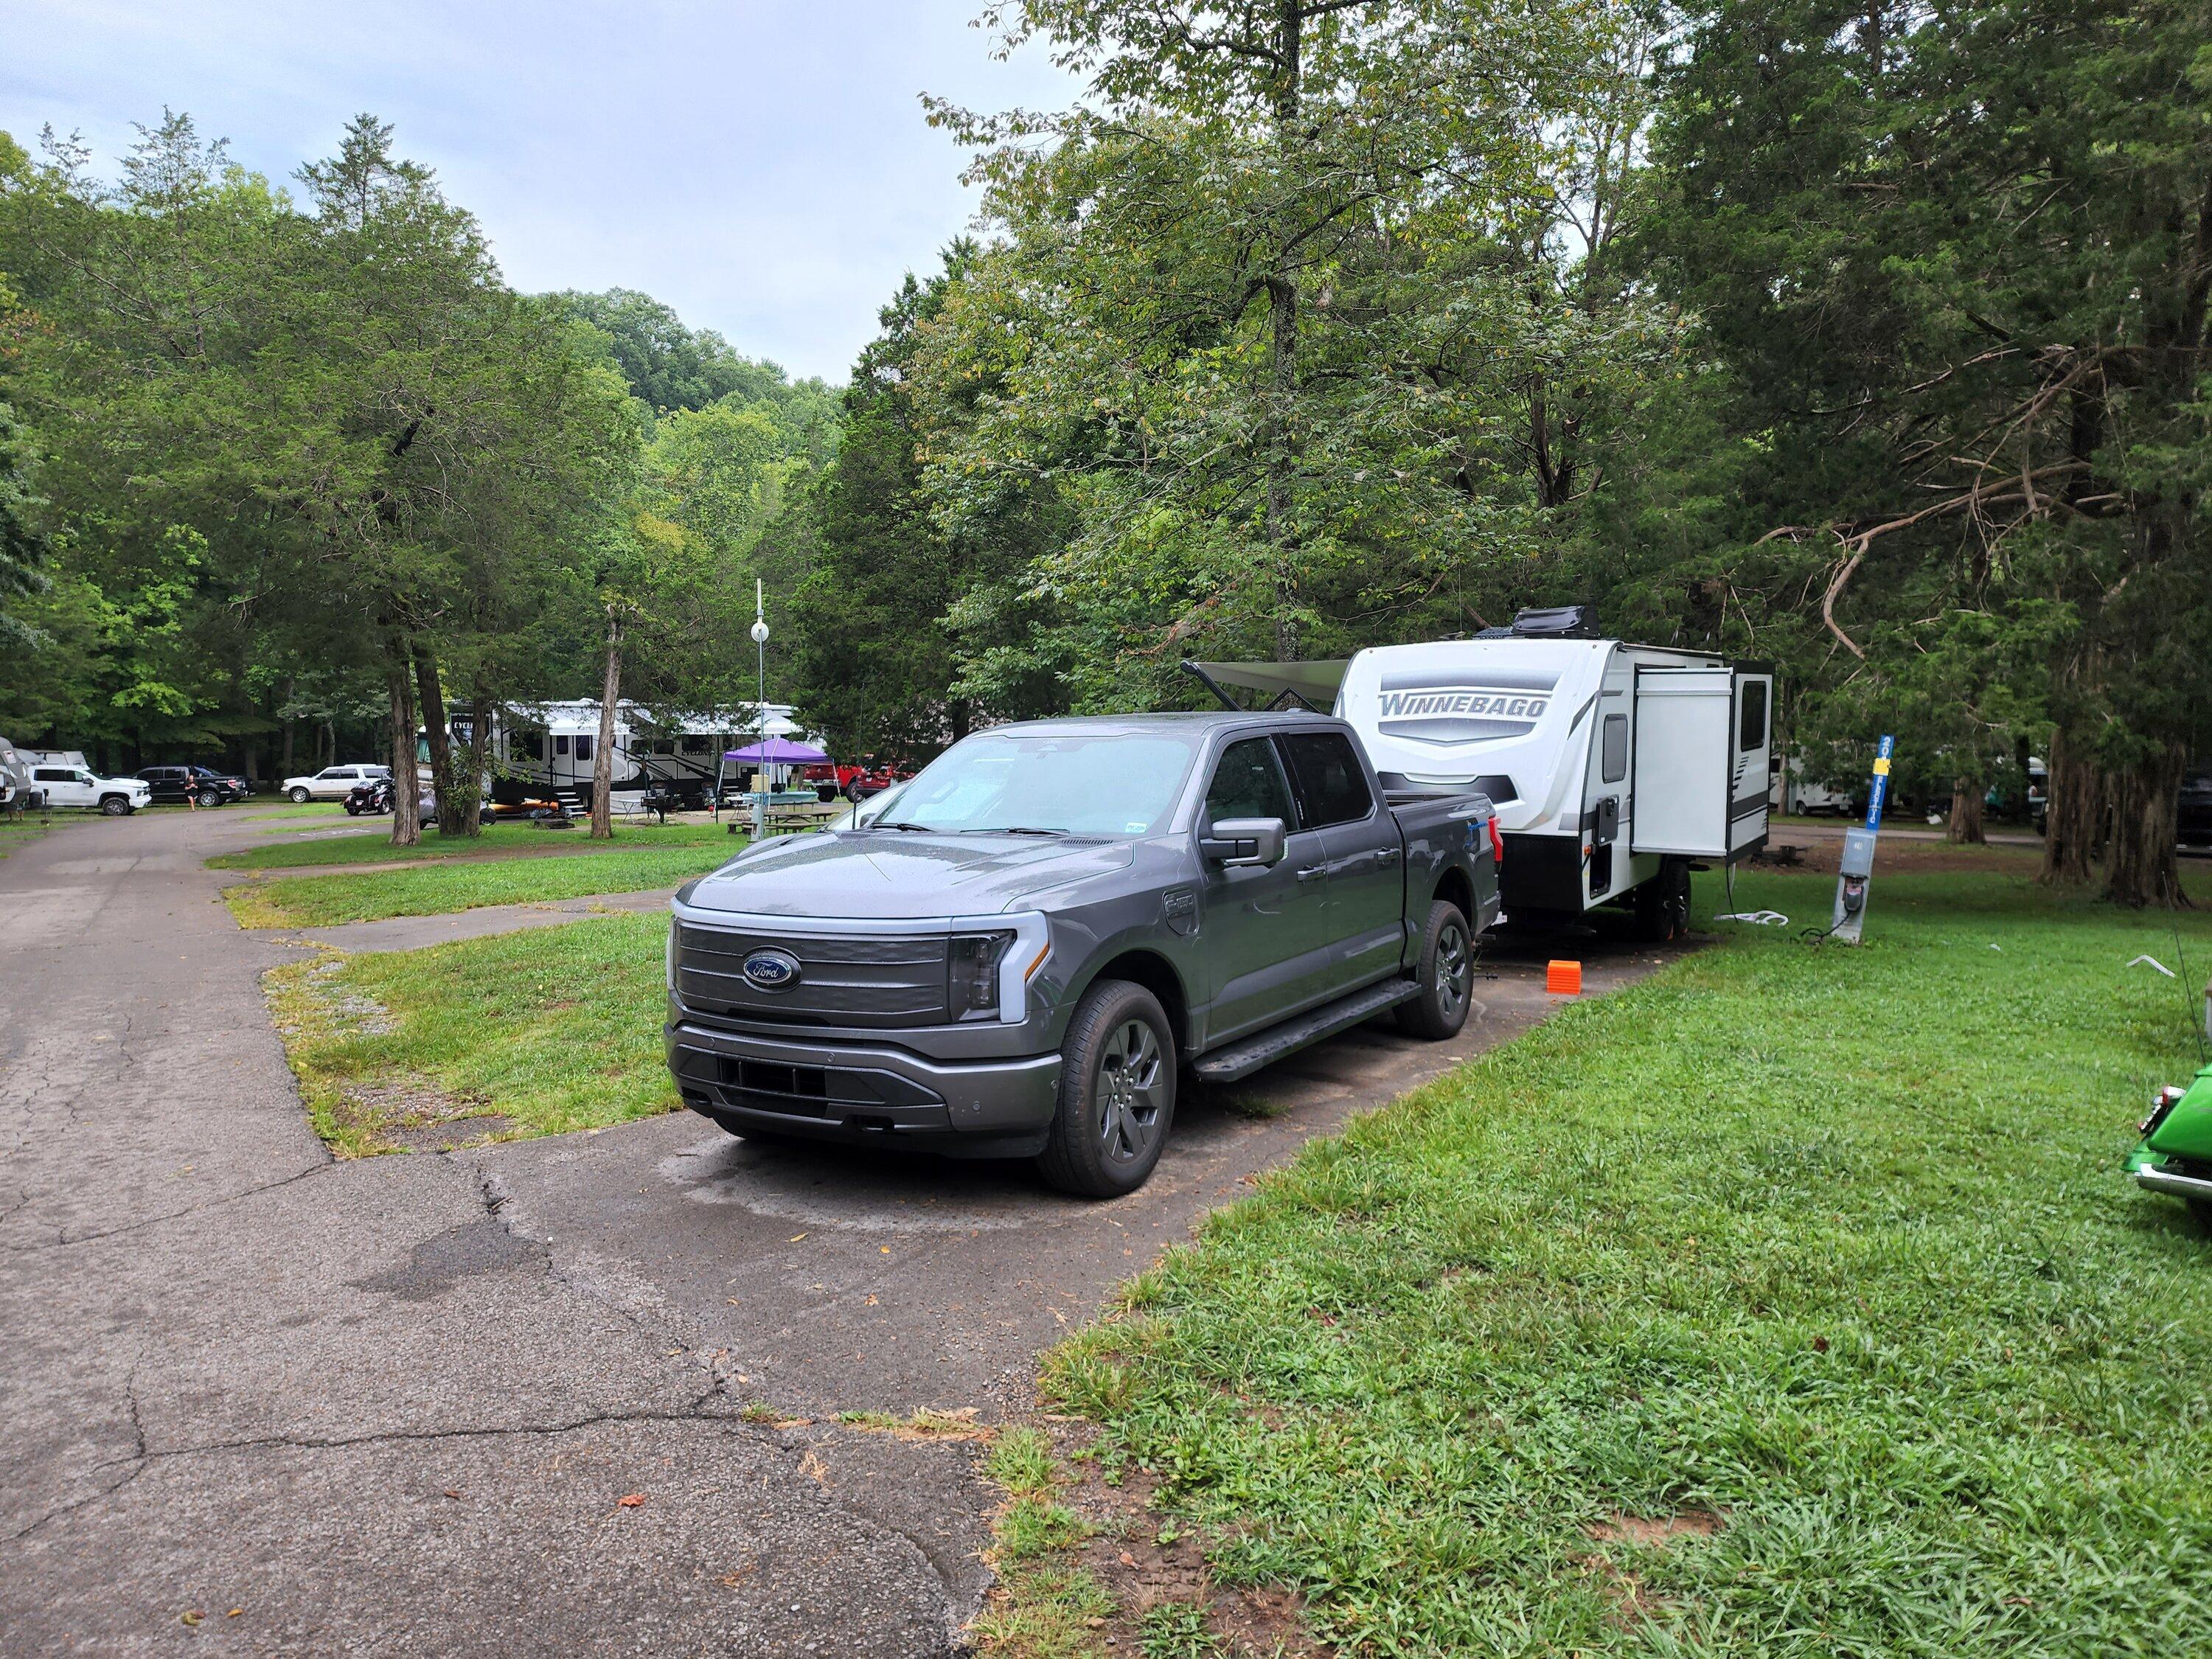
[668,712,1498,1197]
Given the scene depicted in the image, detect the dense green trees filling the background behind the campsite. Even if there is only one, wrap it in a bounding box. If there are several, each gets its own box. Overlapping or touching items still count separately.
[0,0,2212,902]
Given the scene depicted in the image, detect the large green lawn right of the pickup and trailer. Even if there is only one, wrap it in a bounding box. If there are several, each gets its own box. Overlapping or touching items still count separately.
[978,874,2212,1659]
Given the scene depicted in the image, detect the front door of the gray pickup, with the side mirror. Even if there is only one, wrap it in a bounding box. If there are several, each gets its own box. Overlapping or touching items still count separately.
[1199,737,1327,1042]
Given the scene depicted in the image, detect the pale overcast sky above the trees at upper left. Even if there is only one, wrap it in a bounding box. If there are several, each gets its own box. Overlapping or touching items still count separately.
[0,0,1068,380]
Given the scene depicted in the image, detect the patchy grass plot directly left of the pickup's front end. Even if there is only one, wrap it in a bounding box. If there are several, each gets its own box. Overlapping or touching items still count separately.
[268,911,677,1157]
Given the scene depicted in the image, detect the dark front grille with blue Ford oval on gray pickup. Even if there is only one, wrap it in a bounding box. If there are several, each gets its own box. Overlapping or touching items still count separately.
[677,922,949,1029]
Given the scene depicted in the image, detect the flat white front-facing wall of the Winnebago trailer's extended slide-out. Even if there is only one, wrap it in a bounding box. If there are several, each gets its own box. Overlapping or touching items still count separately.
[1628,668,1734,858]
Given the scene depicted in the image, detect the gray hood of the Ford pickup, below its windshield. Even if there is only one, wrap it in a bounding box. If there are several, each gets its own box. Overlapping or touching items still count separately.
[677,830,1135,920]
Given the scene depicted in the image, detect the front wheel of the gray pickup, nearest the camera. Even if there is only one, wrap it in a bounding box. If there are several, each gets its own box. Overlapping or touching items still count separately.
[1037,980,1177,1199]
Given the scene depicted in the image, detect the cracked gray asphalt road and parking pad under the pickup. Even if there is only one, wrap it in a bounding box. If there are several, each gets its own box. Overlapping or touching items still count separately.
[0,812,1659,1659]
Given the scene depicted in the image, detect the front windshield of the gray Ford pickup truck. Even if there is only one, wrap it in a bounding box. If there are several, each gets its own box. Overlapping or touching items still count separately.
[878,732,1197,836]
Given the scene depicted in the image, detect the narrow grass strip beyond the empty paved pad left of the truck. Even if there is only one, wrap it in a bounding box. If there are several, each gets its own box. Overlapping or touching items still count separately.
[223,836,745,927]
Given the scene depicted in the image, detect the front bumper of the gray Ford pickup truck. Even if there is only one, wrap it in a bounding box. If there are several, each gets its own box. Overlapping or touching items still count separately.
[664,1020,1060,1157]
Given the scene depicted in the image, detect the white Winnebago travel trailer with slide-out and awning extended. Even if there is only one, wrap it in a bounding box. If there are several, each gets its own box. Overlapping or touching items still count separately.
[1192,608,1774,938]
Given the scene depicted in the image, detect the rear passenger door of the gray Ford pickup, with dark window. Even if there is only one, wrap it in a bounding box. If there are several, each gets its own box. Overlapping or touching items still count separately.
[1276,732,1405,993]
